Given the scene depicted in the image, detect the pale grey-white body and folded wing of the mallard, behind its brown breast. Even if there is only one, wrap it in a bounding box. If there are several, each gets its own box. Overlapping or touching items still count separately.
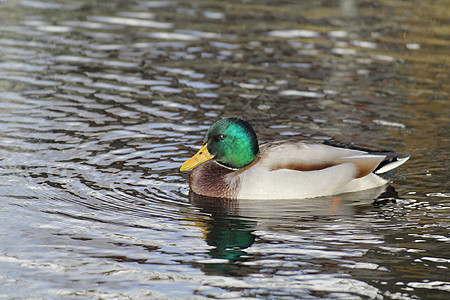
[234,143,402,199]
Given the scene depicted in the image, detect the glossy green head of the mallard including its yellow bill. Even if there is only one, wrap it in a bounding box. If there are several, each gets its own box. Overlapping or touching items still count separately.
[180,118,259,171]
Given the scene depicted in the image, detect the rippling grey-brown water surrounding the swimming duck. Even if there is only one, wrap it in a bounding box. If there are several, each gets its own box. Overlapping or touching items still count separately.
[0,0,450,299]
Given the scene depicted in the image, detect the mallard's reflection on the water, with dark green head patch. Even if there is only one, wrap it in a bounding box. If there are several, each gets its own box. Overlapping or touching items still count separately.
[189,186,398,276]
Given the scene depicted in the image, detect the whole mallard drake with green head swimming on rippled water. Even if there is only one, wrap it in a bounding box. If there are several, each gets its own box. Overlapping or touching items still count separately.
[180,118,409,200]
